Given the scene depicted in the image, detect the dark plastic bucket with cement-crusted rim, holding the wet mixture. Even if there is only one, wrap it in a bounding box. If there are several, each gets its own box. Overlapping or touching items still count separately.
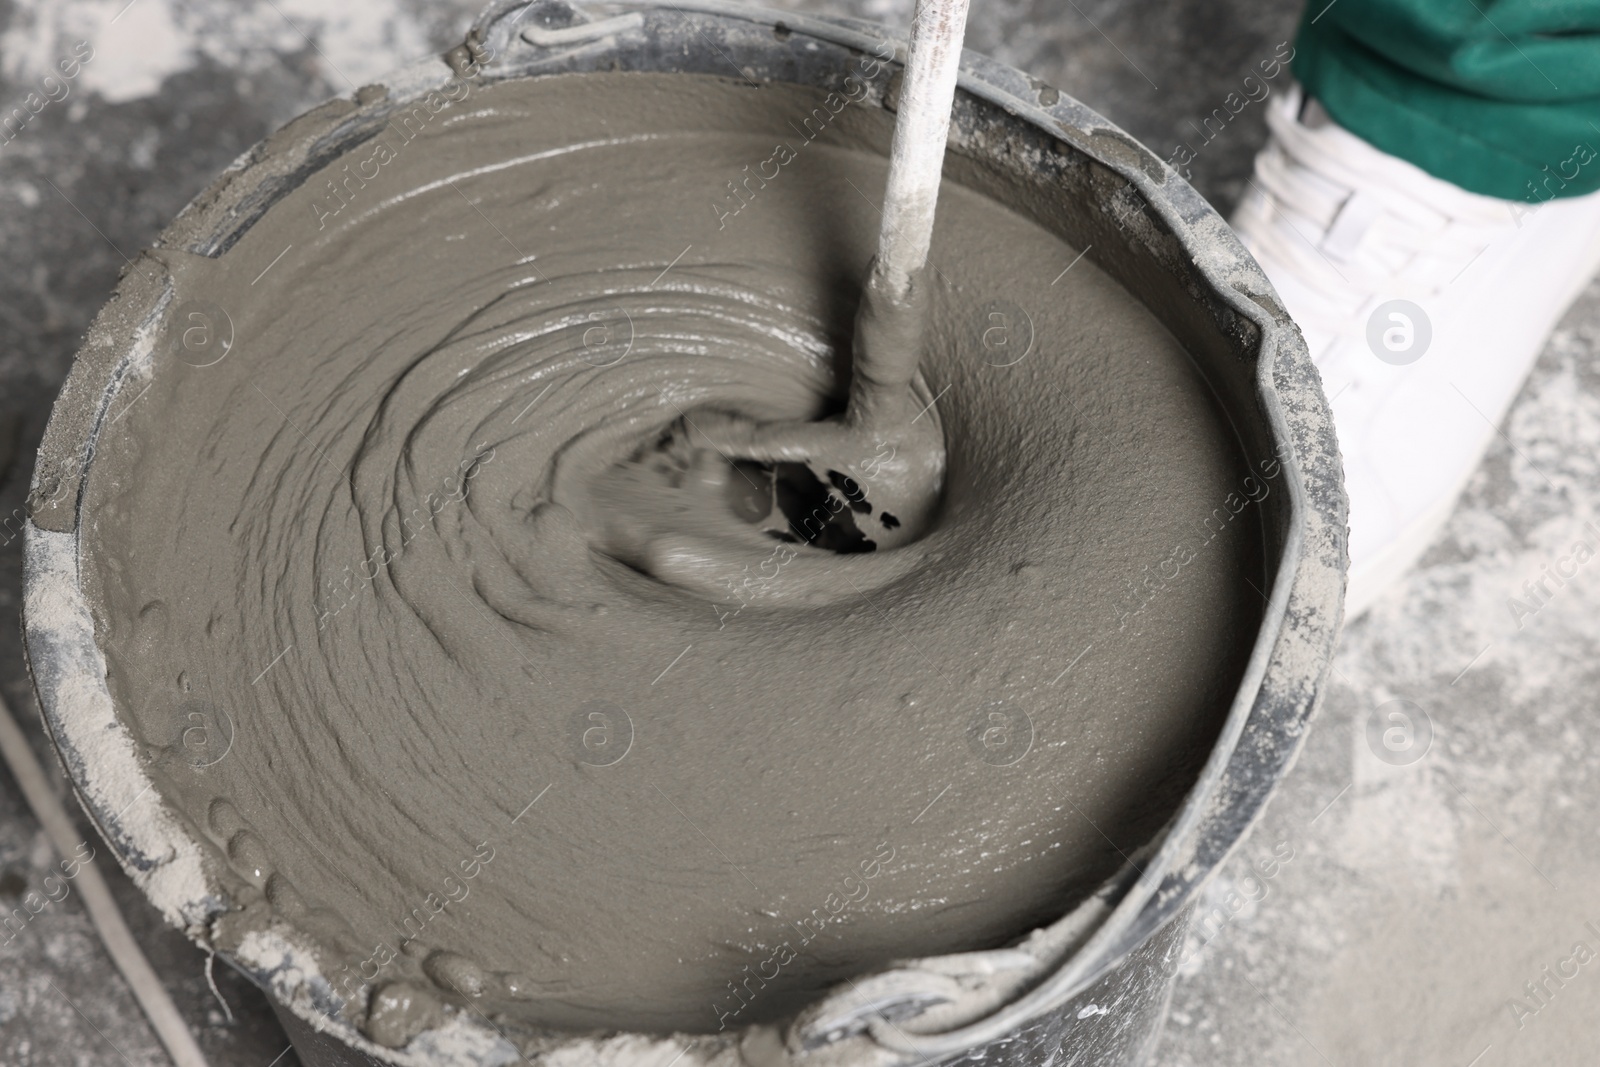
[24,0,1346,1067]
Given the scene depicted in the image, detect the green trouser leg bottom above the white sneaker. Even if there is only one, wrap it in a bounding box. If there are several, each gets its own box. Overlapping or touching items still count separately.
[1291,7,1600,202]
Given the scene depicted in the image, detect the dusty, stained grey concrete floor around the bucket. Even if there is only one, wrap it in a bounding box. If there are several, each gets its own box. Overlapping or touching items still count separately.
[0,0,1600,1067]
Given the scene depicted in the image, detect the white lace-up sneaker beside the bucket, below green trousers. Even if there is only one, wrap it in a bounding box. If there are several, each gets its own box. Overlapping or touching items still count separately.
[1234,86,1600,619]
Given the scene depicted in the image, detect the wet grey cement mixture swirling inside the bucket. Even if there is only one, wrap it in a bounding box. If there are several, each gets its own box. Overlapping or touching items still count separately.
[83,75,1259,1046]
